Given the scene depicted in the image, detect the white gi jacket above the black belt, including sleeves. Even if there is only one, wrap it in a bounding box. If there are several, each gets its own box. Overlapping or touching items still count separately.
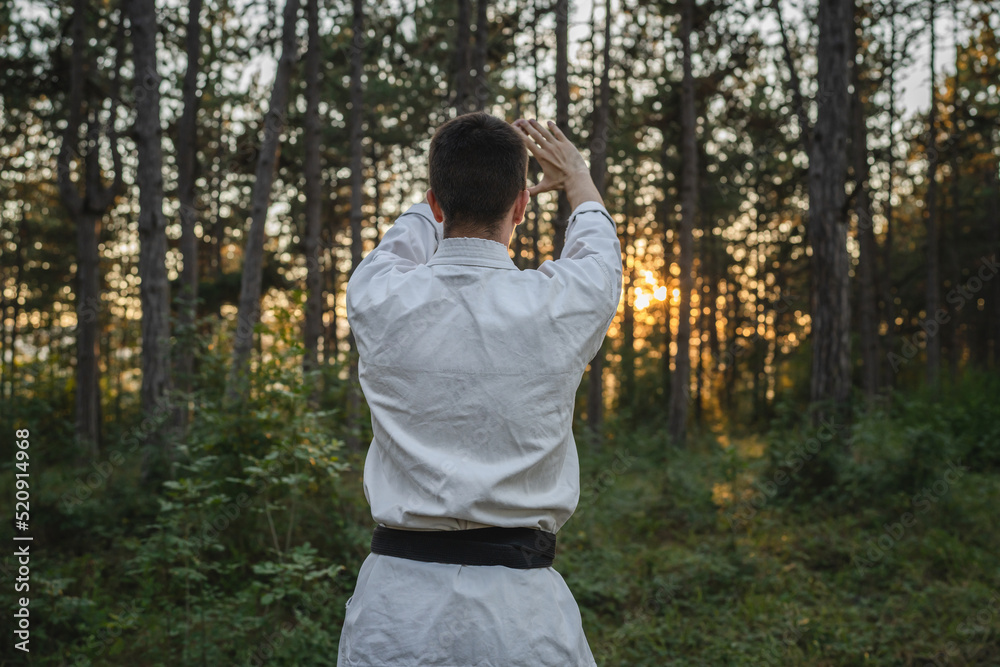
[348,202,621,532]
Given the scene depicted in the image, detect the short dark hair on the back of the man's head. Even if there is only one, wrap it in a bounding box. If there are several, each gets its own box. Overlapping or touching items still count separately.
[430,111,528,233]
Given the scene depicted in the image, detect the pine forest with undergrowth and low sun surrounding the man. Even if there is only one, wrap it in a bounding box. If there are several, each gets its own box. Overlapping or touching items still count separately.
[0,0,1000,667]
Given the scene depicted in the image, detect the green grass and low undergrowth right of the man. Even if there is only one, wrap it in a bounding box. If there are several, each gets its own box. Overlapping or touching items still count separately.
[557,377,1000,667]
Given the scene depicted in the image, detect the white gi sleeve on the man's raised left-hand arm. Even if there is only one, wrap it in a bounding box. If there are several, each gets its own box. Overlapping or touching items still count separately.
[347,202,444,319]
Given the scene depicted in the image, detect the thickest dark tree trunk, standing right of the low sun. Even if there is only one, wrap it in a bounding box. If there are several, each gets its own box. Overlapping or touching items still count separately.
[809,0,854,420]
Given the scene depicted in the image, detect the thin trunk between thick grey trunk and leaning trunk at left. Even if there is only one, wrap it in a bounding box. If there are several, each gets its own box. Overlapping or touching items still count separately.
[174,0,202,427]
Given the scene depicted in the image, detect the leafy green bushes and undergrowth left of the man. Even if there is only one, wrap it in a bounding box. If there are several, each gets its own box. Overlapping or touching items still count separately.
[4,311,367,665]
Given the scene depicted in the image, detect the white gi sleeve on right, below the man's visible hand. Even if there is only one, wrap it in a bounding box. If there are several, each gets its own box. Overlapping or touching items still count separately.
[538,201,622,334]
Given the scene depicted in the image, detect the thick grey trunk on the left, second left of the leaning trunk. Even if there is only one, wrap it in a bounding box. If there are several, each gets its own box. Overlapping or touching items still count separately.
[128,0,171,479]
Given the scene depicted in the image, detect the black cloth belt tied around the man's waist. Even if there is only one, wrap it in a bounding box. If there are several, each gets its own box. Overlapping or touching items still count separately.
[372,526,556,570]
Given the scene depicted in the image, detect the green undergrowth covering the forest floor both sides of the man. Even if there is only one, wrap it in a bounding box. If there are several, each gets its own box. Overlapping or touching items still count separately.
[0,364,1000,667]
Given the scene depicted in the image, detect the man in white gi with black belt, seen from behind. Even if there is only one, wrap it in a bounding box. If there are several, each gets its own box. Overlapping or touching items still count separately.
[338,113,622,667]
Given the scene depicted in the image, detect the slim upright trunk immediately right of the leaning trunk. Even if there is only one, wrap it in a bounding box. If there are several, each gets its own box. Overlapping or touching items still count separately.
[302,0,323,373]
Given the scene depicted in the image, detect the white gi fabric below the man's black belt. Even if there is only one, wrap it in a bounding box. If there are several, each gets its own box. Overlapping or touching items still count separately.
[337,554,597,667]
